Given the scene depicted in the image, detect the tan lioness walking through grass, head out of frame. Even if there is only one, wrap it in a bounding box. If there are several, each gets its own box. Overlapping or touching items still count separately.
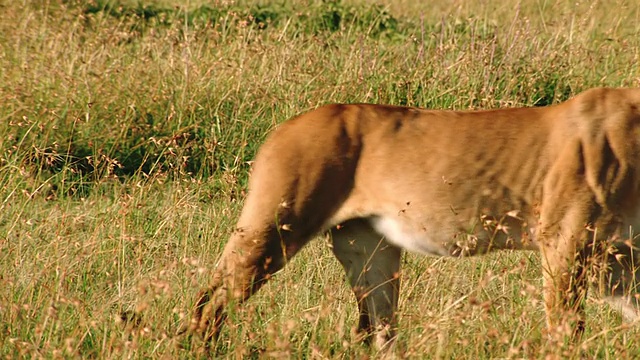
[190,88,640,349]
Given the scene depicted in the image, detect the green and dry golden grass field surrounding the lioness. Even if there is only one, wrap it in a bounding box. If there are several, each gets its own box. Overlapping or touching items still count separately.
[0,0,640,359]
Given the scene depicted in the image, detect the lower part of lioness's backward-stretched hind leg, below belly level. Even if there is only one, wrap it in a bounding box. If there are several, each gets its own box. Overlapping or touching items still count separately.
[189,186,322,347]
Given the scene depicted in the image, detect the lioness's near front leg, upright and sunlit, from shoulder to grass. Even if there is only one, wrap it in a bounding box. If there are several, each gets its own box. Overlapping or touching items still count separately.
[537,139,611,340]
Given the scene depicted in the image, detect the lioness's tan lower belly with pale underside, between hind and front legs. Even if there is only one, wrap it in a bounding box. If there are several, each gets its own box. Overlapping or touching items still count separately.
[326,178,538,256]
